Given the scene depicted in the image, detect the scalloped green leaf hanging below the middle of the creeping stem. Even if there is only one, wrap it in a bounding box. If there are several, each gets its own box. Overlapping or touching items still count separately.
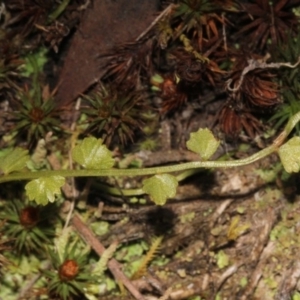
[143,174,178,205]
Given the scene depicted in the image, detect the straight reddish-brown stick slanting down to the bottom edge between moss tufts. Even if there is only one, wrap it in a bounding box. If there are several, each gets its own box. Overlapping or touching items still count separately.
[72,214,144,300]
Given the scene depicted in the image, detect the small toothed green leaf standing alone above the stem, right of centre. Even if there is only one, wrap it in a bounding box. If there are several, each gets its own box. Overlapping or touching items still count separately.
[186,128,220,160]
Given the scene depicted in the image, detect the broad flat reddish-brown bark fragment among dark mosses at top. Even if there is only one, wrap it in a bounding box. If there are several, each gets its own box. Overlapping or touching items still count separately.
[57,0,158,107]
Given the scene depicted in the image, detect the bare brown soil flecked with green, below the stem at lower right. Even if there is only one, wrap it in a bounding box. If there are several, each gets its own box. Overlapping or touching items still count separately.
[95,151,300,300]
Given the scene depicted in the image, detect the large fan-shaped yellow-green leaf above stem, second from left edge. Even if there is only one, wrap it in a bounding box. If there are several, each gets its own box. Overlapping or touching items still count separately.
[72,137,115,170]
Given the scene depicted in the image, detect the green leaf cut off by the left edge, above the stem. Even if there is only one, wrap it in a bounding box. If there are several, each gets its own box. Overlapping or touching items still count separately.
[0,148,30,175]
